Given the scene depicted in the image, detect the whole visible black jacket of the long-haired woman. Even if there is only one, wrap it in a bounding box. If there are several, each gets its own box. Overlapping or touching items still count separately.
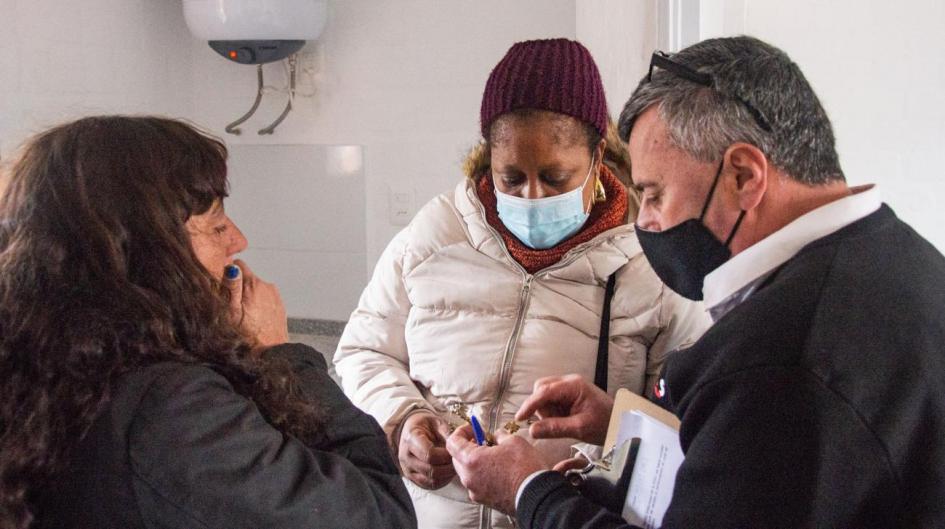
[36,344,417,529]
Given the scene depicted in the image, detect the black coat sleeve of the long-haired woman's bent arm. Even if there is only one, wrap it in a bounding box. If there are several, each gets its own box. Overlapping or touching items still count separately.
[128,340,416,529]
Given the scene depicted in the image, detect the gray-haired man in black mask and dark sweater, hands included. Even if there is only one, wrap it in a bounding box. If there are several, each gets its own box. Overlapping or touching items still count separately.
[448,37,945,528]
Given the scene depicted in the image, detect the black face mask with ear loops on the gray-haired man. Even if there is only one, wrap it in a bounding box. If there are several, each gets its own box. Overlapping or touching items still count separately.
[636,160,745,301]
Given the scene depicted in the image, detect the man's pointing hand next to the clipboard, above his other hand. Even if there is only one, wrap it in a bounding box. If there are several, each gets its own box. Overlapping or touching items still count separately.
[515,375,614,445]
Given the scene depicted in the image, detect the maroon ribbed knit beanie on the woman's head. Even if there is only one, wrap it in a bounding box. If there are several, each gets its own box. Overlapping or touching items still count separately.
[479,39,607,138]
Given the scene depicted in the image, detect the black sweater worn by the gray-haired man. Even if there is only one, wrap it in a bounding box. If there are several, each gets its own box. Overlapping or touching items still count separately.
[518,206,945,529]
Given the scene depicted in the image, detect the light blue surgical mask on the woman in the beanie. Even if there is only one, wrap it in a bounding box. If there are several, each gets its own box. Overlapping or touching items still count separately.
[493,157,594,250]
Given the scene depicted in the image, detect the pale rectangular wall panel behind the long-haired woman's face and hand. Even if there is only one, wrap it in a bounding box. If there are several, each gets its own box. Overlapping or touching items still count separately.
[226,144,366,321]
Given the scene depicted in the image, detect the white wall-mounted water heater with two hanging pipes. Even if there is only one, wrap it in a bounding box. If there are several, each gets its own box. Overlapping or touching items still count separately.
[183,0,328,134]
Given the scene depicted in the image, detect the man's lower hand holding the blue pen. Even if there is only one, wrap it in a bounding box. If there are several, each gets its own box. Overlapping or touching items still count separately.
[446,424,548,514]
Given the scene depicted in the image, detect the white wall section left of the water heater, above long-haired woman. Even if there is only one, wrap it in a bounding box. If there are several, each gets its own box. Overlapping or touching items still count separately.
[0,0,192,157]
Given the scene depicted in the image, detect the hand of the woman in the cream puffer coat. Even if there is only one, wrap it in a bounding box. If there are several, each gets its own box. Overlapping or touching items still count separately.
[397,411,456,490]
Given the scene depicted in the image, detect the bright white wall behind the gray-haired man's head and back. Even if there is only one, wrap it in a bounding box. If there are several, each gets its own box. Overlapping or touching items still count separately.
[701,0,945,251]
